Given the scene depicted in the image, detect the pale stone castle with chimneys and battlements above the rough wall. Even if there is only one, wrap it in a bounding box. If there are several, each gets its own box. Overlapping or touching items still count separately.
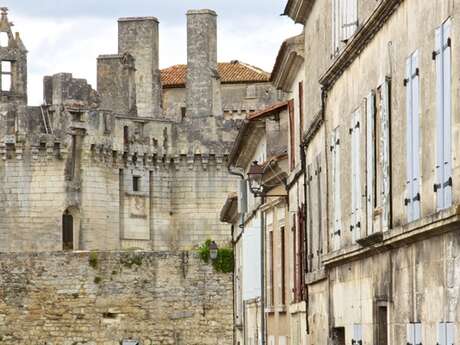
[0,10,279,251]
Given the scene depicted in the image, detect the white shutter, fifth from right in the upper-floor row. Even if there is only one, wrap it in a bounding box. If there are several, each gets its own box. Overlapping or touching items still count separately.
[350,111,362,242]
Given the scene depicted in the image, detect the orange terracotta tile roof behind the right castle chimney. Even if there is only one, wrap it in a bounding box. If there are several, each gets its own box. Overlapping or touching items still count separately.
[161,61,270,88]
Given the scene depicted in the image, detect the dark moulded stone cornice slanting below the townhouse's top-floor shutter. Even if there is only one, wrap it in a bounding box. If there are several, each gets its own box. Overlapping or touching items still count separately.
[319,0,404,90]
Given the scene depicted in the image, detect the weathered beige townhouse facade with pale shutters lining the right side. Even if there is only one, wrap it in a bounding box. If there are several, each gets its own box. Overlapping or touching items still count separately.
[225,0,460,345]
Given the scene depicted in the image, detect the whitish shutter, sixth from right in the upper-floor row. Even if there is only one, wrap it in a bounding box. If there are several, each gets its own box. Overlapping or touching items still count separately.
[330,127,341,250]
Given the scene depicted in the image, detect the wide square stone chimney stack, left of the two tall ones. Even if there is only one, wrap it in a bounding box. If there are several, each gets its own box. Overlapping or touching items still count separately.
[118,17,162,118]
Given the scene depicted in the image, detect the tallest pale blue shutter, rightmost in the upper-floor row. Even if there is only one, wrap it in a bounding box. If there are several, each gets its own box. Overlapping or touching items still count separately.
[433,19,452,210]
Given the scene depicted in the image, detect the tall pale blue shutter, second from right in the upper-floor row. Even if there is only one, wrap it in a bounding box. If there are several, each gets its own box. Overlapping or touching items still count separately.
[404,51,420,222]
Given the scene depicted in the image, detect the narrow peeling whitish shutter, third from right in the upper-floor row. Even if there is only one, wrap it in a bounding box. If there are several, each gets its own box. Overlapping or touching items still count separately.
[381,78,391,231]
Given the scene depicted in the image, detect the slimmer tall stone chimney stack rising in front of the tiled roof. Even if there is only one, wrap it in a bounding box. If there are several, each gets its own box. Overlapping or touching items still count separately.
[187,10,222,118]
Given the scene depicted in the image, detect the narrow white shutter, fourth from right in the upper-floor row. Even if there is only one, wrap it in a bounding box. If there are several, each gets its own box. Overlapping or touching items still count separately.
[366,92,375,235]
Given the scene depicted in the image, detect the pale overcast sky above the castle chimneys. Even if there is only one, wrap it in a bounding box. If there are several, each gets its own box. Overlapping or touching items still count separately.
[6,0,301,105]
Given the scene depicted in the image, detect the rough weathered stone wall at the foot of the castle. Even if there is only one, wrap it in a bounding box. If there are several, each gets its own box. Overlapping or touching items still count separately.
[0,252,232,345]
